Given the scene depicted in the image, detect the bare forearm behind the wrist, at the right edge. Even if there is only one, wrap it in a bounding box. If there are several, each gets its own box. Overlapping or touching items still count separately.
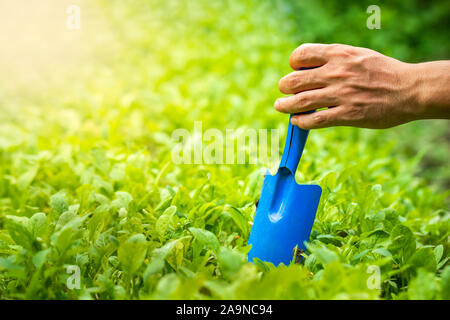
[412,61,450,119]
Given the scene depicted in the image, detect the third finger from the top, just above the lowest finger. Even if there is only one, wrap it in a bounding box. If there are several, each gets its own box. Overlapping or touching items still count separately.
[275,88,338,113]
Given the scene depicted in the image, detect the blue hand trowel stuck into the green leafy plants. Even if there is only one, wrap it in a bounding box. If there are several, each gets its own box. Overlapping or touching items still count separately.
[248,115,322,266]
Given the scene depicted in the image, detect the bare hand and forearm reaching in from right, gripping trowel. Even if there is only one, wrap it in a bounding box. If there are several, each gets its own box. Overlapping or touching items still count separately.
[275,44,450,129]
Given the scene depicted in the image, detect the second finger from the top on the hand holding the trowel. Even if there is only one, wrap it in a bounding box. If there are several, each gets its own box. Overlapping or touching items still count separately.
[278,68,326,94]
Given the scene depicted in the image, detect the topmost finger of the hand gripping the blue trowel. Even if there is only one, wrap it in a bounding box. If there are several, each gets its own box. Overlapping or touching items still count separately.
[289,43,330,70]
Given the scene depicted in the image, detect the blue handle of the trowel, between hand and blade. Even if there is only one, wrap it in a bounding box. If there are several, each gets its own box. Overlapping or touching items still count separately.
[280,114,309,174]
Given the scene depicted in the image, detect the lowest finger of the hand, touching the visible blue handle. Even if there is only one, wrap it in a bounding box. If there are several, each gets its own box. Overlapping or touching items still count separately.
[291,107,347,130]
